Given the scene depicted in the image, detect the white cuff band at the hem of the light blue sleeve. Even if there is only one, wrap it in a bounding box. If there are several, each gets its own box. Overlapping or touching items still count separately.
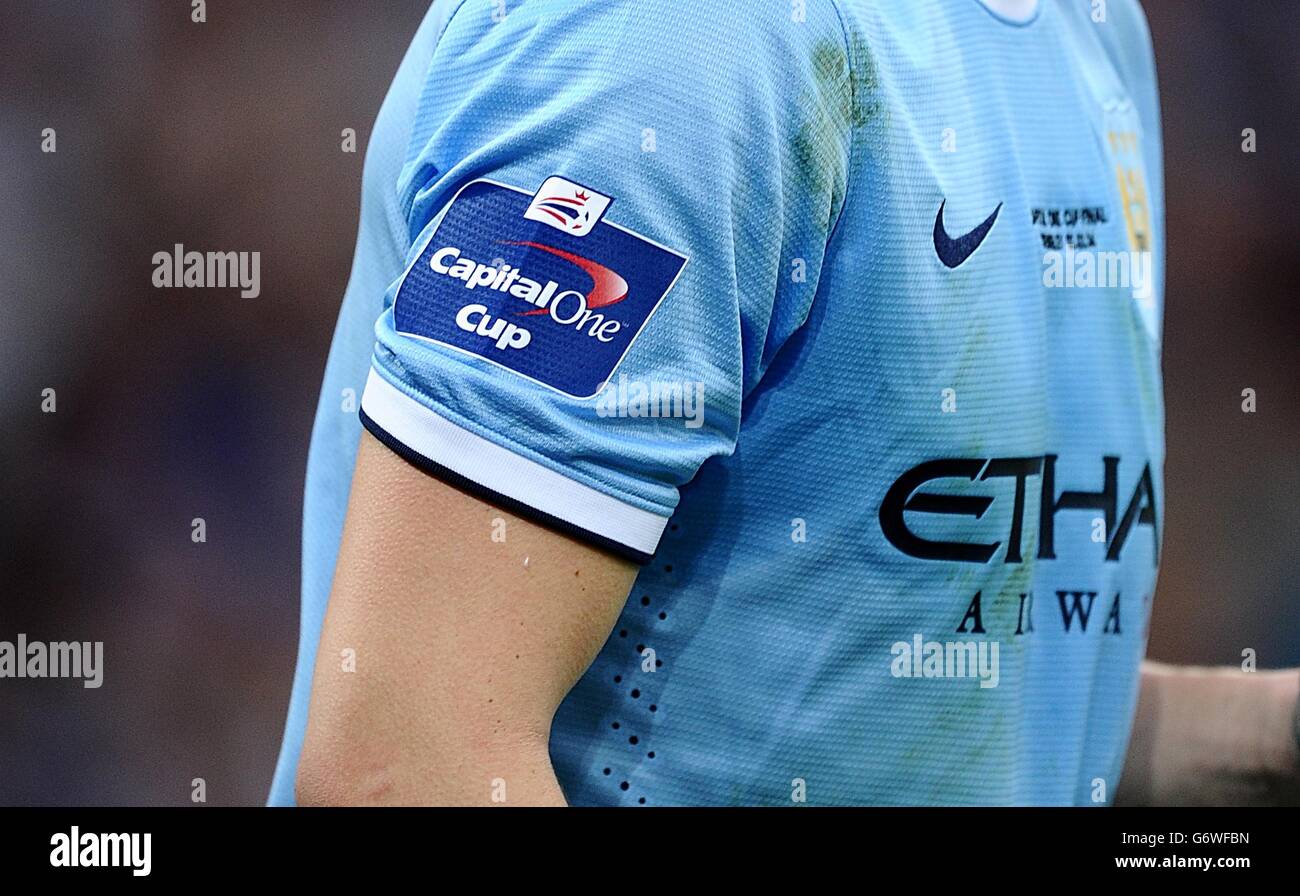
[361,367,668,554]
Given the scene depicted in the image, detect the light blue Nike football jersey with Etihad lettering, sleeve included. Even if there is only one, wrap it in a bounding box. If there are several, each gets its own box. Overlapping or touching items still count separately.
[270,0,1164,805]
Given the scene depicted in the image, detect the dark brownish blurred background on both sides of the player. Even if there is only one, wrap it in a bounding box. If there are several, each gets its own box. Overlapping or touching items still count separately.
[0,0,1300,805]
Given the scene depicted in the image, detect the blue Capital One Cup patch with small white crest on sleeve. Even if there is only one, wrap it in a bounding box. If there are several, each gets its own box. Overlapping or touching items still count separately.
[393,177,688,399]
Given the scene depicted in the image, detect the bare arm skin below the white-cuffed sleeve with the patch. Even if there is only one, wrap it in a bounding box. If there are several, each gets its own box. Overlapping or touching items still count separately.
[298,433,637,805]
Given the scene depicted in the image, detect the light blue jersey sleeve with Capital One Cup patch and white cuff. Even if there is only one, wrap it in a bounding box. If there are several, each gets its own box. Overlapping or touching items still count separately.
[361,0,853,562]
